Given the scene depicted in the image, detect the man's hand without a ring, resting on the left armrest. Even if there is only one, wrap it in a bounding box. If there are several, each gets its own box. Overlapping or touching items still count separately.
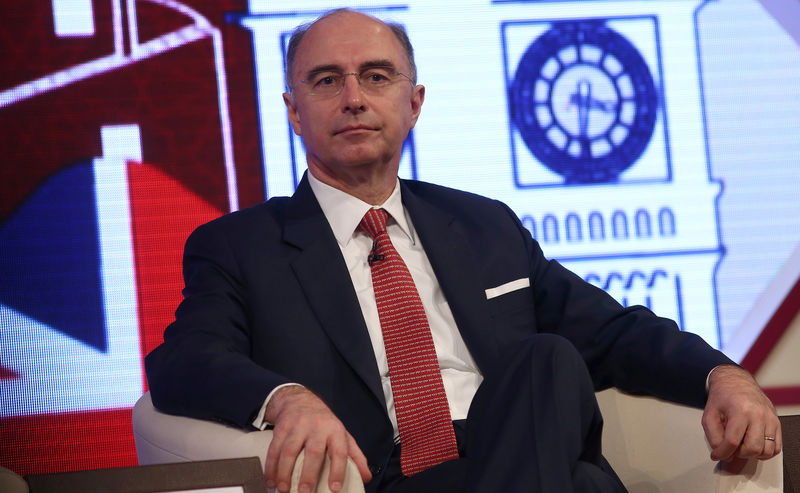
[264,386,372,493]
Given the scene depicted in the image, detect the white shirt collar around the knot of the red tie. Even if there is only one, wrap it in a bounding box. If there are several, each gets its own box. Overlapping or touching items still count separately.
[306,171,414,247]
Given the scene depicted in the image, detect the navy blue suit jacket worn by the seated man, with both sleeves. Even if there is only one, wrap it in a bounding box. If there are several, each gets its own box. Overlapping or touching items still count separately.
[146,174,730,484]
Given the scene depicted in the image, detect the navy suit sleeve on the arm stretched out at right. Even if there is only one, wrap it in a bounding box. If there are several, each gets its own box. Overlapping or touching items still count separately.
[509,201,732,407]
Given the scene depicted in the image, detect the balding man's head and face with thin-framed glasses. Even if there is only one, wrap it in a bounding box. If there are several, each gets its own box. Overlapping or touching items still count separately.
[284,12,424,178]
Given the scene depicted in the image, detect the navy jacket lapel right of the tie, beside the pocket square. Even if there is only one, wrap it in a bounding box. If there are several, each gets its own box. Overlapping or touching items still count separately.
[401,181,499,375]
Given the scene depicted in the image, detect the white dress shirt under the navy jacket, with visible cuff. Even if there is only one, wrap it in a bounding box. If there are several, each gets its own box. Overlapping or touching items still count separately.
[254,173,483,437]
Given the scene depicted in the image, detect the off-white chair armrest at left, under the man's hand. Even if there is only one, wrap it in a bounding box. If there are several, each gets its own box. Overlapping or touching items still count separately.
[132,392,364,493]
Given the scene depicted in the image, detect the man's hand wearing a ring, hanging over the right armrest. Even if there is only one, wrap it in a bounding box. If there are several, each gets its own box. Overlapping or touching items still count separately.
[703,365,782,462]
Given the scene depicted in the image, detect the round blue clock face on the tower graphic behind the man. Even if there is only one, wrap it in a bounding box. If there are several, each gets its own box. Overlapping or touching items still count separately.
[509,20,658,184]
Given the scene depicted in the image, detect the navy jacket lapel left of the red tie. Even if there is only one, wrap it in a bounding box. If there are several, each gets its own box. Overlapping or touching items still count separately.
[284,177,385,403]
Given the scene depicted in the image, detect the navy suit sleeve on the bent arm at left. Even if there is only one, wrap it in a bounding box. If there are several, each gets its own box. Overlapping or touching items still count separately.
[145,219,288,427]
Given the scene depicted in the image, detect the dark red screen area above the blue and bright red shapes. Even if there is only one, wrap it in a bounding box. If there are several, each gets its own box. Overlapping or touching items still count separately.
[0,38,228,220]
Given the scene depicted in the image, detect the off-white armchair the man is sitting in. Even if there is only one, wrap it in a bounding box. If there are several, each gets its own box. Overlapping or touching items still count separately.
[133,390,783,493]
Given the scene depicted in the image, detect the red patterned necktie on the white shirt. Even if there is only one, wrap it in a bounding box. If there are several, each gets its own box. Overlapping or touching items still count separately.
[359,209,458,476]
